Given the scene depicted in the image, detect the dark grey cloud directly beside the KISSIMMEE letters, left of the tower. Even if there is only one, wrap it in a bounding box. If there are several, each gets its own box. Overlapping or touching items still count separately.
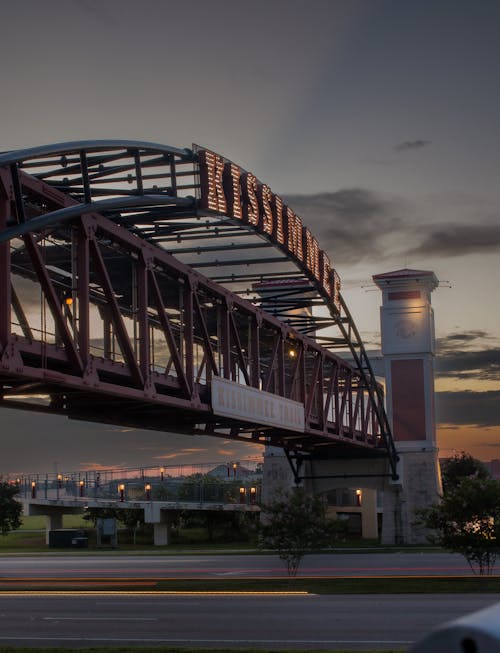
[283,188,404,264]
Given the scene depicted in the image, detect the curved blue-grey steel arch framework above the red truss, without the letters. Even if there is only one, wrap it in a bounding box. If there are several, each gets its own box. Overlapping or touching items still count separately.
[0,140,397,474]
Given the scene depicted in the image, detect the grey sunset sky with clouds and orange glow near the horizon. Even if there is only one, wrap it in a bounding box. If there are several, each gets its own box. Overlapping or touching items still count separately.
[0,0,500,474]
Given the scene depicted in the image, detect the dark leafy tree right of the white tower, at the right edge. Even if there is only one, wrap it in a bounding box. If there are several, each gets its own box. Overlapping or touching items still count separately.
[418,454,500,575]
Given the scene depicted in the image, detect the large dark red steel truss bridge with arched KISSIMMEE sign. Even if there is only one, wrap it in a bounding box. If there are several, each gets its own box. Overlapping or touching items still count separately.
[0,141,397,476]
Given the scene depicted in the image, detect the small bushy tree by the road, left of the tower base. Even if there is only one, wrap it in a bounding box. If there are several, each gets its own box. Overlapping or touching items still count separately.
[259,488,342,577]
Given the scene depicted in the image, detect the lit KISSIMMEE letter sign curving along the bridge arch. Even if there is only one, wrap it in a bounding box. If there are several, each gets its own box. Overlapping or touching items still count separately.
[198,149,340,310]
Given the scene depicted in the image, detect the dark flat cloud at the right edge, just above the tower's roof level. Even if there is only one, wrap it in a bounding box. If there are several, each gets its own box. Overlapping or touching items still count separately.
[408,223,500,257]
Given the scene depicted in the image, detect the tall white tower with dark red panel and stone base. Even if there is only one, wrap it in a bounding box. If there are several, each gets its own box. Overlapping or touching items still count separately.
[373,269,441,544]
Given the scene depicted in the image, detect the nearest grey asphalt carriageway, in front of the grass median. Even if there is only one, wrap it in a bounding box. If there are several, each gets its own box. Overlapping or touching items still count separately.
[0,593,495,650]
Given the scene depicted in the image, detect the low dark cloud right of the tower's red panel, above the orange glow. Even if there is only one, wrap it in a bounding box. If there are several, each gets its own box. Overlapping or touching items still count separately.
[436,390,500,427]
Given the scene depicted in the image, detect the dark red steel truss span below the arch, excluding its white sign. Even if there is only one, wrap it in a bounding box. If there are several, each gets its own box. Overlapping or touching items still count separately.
[0,143,398,468]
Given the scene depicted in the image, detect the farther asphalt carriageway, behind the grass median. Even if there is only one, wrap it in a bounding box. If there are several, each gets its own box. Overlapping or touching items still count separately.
[0,553,492,578]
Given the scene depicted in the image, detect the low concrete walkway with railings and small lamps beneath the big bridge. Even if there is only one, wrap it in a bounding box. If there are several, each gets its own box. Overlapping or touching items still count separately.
[16,461,262,545]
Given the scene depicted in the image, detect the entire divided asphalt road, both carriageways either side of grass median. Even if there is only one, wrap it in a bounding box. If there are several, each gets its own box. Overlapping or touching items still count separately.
[0,552,500,650]
